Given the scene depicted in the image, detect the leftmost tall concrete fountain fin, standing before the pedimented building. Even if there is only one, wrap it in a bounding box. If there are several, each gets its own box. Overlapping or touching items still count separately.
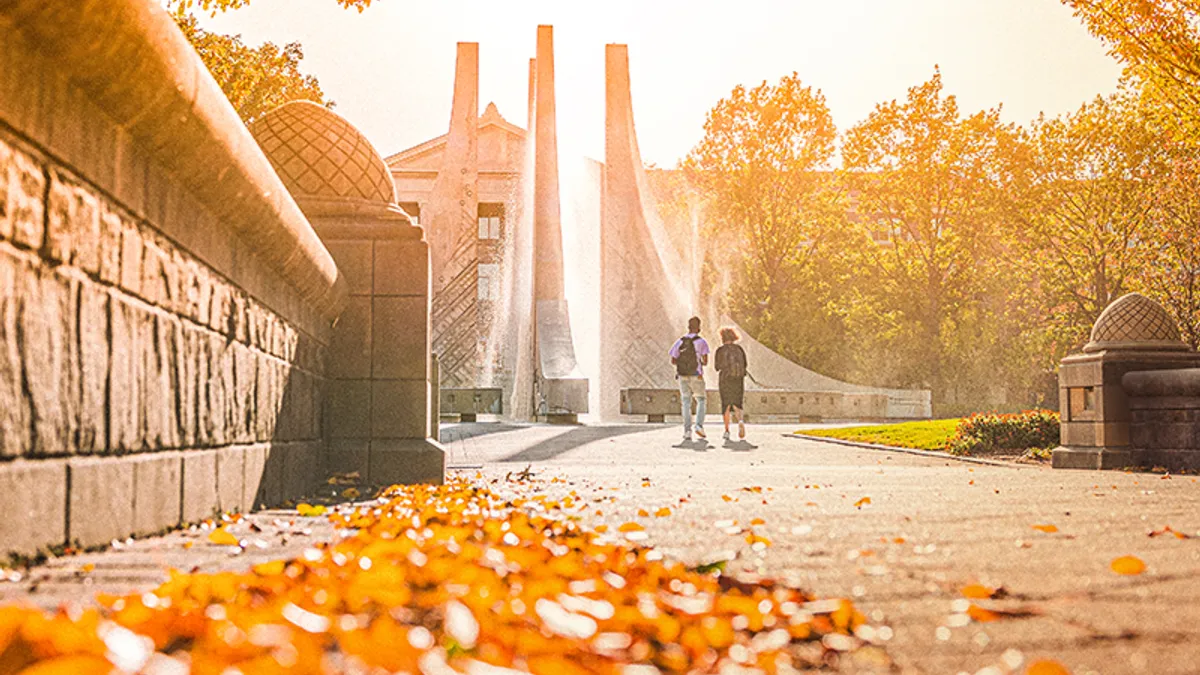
[421,42,481,387]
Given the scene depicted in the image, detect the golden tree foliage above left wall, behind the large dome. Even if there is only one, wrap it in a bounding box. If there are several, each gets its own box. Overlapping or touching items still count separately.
[174,12,334,124]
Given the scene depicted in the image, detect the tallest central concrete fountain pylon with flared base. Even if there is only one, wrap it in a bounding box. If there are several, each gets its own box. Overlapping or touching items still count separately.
[532,25,588,419]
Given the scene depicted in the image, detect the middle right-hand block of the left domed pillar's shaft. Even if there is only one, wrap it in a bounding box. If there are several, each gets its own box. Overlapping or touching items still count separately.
[371,297,430,380]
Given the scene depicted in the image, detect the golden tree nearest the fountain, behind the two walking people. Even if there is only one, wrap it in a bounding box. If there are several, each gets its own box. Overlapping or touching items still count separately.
[682,73,842,357]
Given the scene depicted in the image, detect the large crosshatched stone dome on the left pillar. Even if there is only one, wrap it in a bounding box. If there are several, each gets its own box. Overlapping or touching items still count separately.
[250,101,396,204]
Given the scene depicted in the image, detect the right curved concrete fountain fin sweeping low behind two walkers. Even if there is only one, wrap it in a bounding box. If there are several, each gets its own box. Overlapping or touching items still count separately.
[599,44,930,418]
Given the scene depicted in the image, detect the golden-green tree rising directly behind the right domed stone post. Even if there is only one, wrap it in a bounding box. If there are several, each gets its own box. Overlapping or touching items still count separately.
[1018,92,1158,347]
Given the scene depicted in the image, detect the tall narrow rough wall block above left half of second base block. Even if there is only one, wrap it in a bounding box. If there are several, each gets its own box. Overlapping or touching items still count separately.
[78,281,109,453]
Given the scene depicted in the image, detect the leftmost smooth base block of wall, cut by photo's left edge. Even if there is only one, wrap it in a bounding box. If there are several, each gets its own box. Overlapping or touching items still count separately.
[0,460,67,555]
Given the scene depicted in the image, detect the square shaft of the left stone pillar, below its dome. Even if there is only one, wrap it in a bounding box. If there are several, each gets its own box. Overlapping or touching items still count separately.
[311,208,445,484]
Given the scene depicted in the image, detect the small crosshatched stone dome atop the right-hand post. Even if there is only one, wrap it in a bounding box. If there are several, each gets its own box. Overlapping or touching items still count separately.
[1084,293,1190,353]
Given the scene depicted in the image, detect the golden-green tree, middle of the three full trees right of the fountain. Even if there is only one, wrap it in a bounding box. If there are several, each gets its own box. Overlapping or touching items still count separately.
[842,70,1014,404]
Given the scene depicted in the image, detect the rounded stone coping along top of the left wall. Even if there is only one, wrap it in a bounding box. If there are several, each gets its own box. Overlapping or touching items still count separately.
[0,0,348,322]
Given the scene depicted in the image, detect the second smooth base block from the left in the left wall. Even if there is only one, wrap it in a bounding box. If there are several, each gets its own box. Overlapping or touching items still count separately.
[67,458,133,546]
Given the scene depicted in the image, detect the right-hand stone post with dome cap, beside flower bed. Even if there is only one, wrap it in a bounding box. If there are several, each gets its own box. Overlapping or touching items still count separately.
[1051,293,1200,468]
